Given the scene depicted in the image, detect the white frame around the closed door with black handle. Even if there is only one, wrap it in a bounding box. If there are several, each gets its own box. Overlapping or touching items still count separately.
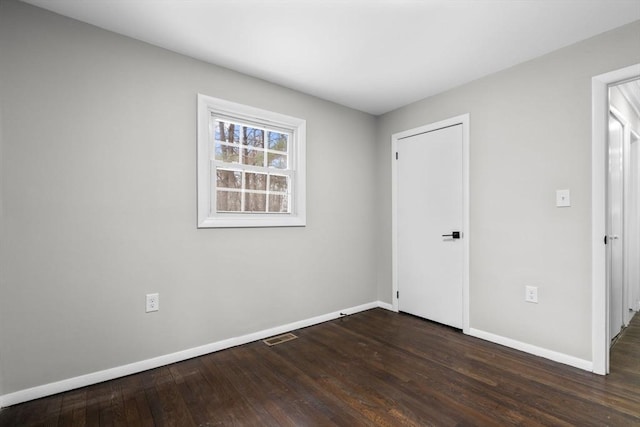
[391,113,470,334]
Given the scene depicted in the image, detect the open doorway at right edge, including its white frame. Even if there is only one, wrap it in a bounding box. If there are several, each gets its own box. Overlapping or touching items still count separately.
[591,64,640,375]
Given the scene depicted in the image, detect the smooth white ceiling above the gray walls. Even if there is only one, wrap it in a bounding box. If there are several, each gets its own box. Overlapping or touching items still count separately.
[23,0,640,114]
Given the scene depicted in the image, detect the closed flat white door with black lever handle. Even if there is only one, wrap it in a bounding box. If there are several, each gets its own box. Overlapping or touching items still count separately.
[396,124,464,328]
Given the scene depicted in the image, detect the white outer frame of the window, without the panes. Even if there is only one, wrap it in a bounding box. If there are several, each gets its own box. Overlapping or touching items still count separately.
[197,94,307,228]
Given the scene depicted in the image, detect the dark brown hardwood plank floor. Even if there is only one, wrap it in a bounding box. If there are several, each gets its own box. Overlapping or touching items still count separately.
[0,309,640,426]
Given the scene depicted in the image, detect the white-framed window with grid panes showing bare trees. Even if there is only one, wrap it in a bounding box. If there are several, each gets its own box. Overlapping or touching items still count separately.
[198,94,306,228]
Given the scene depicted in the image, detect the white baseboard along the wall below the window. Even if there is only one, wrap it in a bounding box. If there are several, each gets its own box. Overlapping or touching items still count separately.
[0,301,390,408]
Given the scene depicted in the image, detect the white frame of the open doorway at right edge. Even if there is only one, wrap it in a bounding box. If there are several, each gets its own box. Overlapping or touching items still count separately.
[591,64,640,375]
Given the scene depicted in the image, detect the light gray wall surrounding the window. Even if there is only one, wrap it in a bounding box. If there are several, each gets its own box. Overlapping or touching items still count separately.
[0,1,377,393]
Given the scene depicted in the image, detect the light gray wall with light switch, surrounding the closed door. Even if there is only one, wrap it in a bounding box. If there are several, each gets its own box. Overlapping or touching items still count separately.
[377,22,640,360]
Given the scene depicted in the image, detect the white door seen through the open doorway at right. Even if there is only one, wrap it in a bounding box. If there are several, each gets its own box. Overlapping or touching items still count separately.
[607,115,624,339]
